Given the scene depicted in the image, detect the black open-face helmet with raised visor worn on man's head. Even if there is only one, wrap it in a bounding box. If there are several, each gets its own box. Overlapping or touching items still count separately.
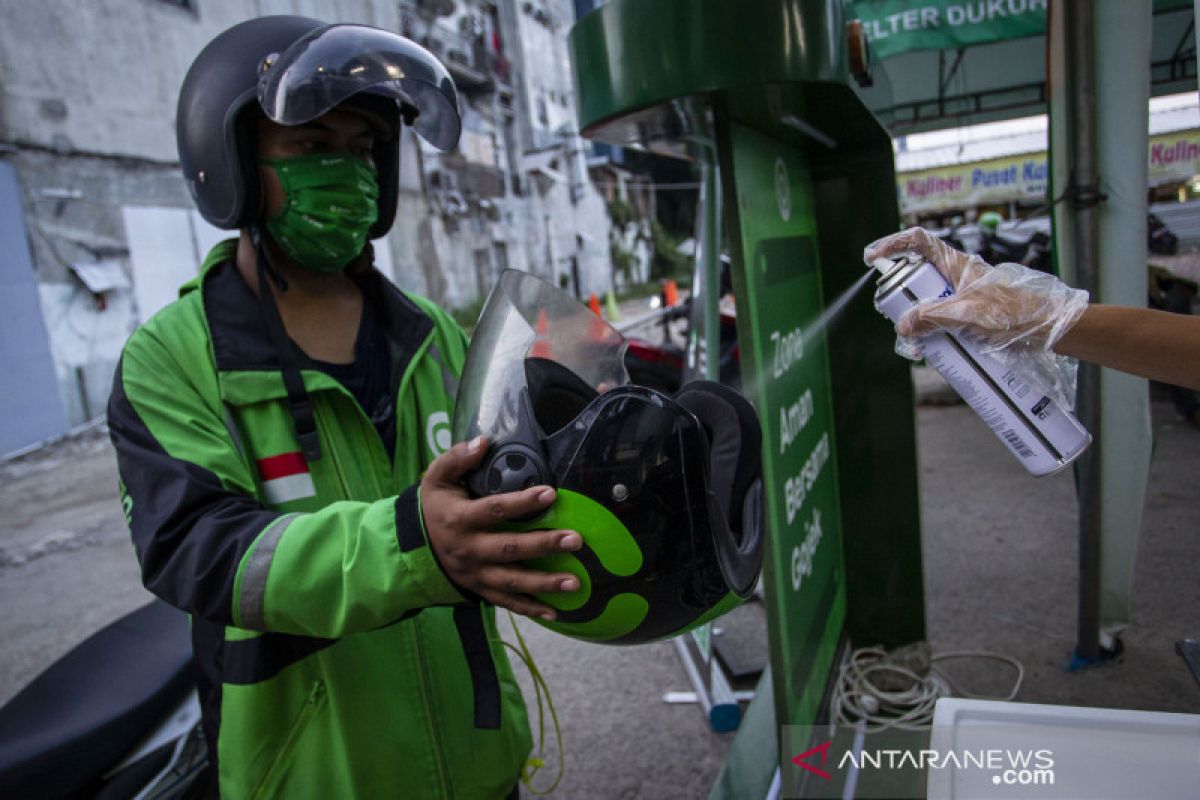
[175,17,461,239]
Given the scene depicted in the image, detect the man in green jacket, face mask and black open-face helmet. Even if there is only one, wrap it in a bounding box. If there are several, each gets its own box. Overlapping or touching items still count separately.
[108,17,581,798]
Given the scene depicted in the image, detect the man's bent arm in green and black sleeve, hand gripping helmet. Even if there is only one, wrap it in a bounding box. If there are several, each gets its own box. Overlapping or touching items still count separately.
[109,331,578,638]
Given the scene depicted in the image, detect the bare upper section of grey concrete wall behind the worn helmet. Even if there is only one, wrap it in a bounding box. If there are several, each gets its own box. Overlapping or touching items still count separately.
[0,0,398,163]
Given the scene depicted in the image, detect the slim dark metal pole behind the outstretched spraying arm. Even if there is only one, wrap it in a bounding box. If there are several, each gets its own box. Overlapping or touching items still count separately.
[1063,0,1103,661]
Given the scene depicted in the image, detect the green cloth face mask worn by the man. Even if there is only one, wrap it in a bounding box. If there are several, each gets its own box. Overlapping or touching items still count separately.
[262,152,379,272]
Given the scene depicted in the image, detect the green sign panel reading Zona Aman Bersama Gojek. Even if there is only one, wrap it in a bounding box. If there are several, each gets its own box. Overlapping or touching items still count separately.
[730,125,846,720]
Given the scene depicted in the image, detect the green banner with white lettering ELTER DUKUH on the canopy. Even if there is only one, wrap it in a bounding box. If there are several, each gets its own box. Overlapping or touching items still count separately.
[847,0,1048,60]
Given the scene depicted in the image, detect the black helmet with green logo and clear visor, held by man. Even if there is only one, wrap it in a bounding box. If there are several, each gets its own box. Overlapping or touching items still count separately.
[454,270,763,644]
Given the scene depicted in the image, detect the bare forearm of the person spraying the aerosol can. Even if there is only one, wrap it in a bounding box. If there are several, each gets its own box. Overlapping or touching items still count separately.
[1054,305,1200,391]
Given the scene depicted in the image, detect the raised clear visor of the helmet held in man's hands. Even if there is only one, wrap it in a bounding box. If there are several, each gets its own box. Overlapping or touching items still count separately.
[454,270,629,441]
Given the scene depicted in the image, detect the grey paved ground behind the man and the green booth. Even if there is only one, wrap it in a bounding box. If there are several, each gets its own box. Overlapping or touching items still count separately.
[0,377,1200,799]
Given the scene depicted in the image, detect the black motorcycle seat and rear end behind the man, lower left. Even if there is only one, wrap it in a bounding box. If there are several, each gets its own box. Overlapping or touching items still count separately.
[0,600,209,800]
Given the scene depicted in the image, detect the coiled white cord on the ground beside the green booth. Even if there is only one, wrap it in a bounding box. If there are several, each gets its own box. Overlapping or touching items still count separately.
[830,648,1025,733]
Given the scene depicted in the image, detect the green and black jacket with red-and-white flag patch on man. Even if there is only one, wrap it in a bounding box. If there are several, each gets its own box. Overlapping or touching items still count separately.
[108,242,530,799]
